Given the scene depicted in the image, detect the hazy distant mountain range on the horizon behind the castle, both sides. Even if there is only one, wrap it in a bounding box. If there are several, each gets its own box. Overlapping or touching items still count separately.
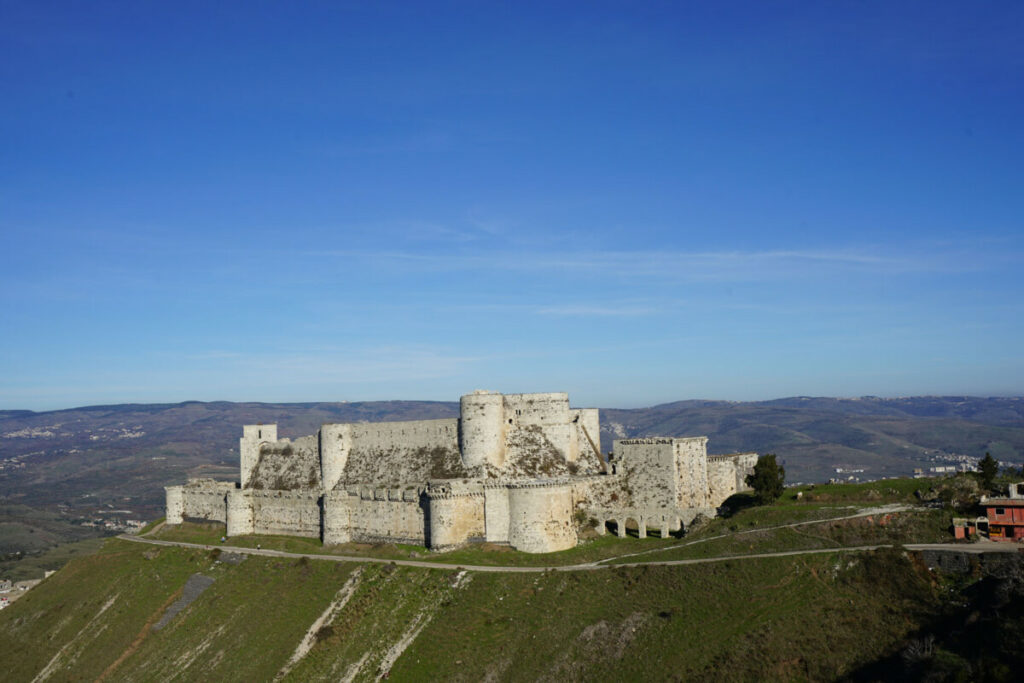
[0,396,1024,518]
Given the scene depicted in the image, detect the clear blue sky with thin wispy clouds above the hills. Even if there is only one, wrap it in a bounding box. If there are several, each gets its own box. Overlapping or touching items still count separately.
[0,0,1024,410]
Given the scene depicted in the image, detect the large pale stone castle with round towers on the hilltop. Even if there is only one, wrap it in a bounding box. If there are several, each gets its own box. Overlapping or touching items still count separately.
[166,391,757,553]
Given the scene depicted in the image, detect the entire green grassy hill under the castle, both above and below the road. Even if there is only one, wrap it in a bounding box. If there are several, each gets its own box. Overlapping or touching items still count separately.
[0,480,1024,681]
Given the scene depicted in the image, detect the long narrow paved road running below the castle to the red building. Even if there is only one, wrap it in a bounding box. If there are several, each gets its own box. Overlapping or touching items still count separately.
[118,535,1018,573]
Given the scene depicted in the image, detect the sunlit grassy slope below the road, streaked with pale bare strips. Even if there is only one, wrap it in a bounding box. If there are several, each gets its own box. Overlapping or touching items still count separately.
[0,540,937,681]
